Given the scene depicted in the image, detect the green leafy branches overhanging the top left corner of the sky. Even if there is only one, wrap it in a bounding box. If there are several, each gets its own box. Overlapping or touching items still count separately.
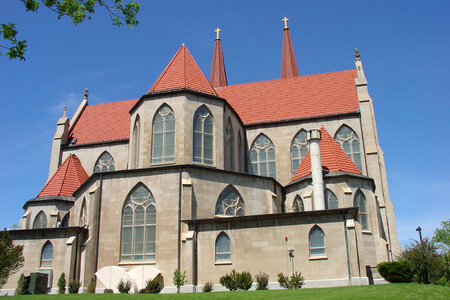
[0,0,139,60]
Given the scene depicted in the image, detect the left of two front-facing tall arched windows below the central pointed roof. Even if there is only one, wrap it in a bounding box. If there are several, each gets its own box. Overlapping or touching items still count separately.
[152,104,175,163]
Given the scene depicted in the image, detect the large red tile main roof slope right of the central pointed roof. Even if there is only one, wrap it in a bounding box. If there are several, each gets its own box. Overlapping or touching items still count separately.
[216,70,358,125]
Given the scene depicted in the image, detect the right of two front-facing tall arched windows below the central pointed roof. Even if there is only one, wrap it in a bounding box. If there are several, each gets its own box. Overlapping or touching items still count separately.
[193,106,214,165]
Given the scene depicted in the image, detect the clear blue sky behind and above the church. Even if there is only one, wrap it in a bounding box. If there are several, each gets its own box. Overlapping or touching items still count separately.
[0,0,450,244]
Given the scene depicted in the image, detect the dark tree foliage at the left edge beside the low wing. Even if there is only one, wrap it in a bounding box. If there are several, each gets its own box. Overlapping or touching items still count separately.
[0,230,24,288]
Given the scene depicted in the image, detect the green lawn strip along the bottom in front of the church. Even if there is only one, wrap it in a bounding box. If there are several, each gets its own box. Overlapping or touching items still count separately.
[7,283,450,300]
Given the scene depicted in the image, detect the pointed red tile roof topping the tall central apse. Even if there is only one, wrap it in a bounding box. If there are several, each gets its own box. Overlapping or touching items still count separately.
[148,45,217,96]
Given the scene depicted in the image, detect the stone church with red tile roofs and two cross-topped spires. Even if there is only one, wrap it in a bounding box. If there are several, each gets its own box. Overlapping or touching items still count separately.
[1,18,401,294]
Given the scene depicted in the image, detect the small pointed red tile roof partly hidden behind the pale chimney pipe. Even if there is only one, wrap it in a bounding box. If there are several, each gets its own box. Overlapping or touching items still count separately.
[292,126,361,181]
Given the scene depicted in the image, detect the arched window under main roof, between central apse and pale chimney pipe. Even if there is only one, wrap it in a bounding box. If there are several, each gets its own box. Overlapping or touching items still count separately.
[250,134,277,178]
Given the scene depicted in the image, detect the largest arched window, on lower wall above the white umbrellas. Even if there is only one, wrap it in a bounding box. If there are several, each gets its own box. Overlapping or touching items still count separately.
[121,184,156,261]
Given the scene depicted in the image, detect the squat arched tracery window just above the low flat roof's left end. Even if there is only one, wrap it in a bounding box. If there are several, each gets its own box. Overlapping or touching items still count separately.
[215,186,245,216]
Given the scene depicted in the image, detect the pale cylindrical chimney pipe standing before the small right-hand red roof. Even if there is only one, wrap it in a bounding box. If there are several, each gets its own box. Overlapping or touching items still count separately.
[307,129,325,210]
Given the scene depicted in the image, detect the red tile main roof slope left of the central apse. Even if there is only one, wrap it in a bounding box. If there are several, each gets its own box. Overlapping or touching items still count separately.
[69,99,138,145]
